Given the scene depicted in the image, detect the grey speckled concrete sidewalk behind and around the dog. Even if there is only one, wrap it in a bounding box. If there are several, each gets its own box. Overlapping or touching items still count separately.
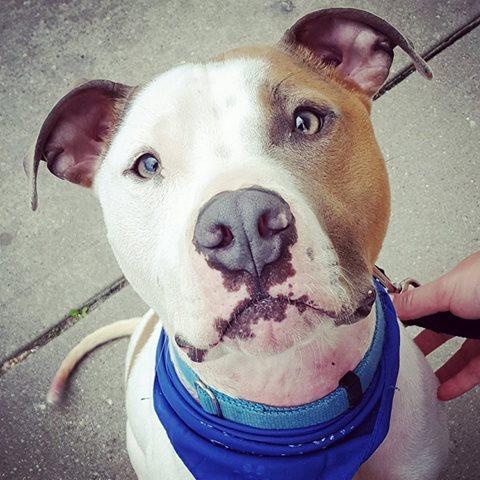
[0,0,480,480]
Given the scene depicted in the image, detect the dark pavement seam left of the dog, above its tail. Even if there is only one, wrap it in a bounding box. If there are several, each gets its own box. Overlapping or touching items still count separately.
[0,276,128,377]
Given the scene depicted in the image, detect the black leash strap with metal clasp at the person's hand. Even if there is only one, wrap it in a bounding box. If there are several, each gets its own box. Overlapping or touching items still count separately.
[373,266,480,340]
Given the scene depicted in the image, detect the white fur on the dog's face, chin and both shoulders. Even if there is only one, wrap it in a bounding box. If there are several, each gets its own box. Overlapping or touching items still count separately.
[47,58,448,480]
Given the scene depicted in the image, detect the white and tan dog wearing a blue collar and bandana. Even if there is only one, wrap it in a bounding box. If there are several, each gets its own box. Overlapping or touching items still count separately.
[26,8,448,480]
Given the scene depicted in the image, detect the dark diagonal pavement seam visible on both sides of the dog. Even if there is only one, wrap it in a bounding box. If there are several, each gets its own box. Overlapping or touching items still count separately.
[0,9,480,377]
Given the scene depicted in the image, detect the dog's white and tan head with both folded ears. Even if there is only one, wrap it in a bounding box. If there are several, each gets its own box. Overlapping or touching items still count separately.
[26,9,429,362]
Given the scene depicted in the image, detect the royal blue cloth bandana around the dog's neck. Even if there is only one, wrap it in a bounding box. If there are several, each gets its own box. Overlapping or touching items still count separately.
[154,281,400,480]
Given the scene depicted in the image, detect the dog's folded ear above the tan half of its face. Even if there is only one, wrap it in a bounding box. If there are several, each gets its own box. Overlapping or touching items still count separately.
[282,8,433,97]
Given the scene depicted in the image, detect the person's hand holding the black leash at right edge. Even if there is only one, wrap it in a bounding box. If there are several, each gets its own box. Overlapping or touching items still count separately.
[393,252,480,400]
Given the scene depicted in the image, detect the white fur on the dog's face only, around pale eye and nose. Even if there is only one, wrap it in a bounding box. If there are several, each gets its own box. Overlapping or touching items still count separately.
[94,59,347,360]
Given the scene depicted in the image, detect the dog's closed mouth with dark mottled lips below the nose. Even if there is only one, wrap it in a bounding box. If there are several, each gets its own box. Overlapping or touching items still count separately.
[175,295,374,363]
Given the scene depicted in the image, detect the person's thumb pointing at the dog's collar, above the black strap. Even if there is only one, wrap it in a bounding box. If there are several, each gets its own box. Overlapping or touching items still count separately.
[392,277,450,320]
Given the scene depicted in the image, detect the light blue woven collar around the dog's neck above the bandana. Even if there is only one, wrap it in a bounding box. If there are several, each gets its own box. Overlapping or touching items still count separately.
[170,280,385,429]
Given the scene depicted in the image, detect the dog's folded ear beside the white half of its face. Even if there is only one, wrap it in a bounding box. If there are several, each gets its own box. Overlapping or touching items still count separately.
[24,80,133,210]
